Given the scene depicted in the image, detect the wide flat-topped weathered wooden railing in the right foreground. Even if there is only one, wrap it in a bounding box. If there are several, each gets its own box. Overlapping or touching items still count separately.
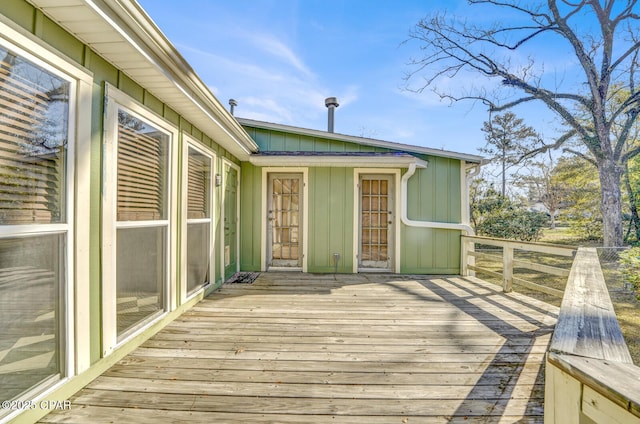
[544,248,640,424]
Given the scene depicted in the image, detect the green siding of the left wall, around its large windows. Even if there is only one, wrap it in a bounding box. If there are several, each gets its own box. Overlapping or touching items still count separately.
[0,0,239,421]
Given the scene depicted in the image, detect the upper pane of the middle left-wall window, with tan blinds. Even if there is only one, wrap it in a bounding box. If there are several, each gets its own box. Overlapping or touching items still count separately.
[117,110,169,221]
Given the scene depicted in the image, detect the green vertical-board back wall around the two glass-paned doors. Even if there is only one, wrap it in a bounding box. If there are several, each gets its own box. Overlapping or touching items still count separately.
[240,127,463,274]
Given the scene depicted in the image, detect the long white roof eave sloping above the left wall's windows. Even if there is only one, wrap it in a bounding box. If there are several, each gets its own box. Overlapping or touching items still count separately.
[28,0,258,160]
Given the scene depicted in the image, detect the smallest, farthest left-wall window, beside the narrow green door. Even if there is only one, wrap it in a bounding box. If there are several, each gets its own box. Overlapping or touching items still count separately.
[186,146,213,295]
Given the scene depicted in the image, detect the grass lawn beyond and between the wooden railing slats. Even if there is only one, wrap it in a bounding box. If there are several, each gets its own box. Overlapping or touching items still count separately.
[476,227,640,366]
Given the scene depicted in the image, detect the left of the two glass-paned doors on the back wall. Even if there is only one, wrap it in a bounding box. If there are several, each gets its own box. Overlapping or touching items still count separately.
[266,173,303,269]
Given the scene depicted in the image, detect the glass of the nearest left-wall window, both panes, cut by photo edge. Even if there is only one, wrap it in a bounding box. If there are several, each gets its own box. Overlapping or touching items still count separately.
[0,45,76,406]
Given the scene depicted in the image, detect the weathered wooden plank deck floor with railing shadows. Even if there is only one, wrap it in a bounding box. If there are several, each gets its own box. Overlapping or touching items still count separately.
[42,273,558,424]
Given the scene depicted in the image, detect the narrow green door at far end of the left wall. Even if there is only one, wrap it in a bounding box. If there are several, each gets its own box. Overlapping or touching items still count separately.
[223,164,238,280]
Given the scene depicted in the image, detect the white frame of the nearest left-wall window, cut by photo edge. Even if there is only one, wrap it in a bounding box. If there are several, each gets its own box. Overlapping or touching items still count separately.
[0,19,93,419]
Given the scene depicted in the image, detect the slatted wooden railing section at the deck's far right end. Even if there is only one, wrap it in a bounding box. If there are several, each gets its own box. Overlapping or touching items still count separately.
[462,236,576,298]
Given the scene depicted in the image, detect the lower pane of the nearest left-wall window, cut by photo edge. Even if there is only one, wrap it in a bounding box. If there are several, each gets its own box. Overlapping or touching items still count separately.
[0,234,65,400]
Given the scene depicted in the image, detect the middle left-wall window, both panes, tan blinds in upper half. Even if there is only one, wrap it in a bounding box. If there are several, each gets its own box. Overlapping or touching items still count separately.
[116,108,171,339]
